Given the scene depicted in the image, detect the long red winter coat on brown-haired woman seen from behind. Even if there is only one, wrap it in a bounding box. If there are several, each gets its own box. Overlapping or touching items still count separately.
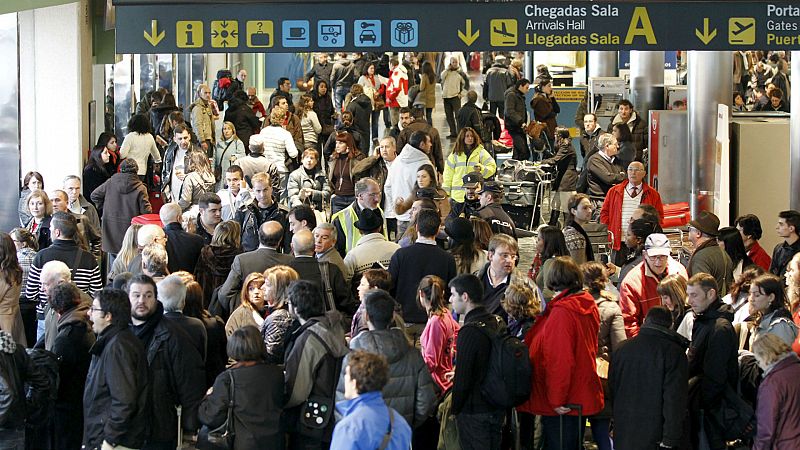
[518,291,603,416]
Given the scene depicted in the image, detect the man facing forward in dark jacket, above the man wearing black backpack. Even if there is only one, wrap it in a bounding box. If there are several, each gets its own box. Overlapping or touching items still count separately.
[478,233,536,321]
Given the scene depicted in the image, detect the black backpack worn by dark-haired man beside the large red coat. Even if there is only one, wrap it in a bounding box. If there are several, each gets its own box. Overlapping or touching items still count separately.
[468,316,533,408]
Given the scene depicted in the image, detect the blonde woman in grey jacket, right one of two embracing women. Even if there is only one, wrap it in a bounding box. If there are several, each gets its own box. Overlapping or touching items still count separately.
[261,266,300,364]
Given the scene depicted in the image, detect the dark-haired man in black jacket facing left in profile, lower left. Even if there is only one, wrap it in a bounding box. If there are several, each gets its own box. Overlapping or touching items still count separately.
[83,289,149,449]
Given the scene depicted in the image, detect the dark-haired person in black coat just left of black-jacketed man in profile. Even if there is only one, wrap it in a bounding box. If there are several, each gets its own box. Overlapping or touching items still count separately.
[48,283,95,449]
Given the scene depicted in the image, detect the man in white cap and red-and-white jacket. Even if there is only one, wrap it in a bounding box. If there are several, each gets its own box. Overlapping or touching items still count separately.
[619,233,688,337]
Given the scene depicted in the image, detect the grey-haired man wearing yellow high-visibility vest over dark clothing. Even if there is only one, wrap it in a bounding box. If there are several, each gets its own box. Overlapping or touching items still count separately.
[331,178,386,257]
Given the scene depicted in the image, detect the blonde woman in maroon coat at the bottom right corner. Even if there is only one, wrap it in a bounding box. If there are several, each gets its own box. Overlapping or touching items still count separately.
[752,334,800,450]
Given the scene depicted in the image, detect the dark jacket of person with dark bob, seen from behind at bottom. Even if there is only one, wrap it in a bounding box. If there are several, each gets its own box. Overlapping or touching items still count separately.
[199,362,285,450]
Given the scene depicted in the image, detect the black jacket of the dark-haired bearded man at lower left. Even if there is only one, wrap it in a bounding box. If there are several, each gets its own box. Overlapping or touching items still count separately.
[133,302,206,446]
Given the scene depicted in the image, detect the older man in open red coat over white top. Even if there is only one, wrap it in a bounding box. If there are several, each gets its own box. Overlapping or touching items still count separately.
[600,161,664,266]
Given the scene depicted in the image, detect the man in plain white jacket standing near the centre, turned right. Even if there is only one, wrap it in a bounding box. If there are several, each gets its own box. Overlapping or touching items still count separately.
[384,131,432,237]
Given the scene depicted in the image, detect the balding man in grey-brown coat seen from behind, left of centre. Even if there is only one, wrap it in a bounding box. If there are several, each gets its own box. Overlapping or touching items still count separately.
[218,220,292,314]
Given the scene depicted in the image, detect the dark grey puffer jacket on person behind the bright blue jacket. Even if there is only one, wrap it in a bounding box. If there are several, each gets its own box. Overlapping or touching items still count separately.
[336,328,437,427]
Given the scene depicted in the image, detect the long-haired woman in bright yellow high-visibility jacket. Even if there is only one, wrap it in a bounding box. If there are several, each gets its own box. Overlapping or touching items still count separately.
[442,127,497,203]
